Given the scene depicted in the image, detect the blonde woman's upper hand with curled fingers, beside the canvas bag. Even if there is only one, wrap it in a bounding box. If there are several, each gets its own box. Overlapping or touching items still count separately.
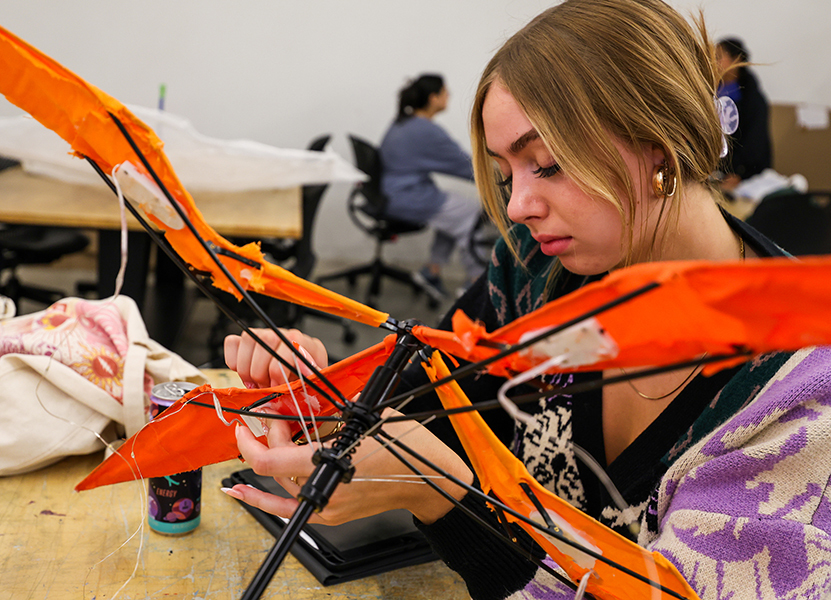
[225,329,329,388]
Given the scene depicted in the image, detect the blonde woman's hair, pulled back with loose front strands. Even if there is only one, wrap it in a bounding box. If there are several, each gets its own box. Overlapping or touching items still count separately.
[471,0,723,263]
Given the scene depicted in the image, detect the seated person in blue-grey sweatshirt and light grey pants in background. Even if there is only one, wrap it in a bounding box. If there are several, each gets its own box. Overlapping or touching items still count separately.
[380,74,482,300]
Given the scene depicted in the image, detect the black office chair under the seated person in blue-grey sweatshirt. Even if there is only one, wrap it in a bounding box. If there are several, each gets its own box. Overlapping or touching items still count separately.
[317,135,426,306]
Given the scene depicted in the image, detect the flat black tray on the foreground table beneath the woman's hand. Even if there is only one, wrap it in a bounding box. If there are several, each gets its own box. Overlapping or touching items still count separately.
[222,469,438,585]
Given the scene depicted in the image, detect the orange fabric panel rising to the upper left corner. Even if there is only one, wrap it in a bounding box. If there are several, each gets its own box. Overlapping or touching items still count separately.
[0,27,389,327]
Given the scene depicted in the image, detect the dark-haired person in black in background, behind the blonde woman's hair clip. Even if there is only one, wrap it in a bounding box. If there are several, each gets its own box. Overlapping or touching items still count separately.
[716,38,771,192]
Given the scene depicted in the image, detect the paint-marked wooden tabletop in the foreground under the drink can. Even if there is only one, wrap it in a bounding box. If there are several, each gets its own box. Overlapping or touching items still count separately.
[0,374,468,600]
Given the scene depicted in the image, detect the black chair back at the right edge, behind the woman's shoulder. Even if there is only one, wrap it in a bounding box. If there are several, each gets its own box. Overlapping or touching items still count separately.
[747,191,831,256]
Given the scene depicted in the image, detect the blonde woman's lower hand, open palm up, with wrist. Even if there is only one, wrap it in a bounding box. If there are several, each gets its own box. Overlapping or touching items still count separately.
[223,409,473,525]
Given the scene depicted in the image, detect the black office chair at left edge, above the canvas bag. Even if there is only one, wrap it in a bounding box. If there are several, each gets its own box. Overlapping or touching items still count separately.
[0,157,89,309]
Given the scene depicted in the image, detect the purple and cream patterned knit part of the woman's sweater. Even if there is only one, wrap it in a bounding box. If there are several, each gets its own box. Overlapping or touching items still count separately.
[506,347,831,600]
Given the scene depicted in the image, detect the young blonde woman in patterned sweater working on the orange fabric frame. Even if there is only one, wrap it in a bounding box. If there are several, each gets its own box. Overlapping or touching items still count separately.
[226,0,831,599]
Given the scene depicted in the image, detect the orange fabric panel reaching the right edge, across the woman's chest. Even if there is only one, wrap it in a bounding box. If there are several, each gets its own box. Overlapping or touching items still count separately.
[414,257,831,375]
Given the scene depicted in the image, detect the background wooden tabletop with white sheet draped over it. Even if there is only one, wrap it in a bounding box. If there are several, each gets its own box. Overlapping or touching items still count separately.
[0,167,303,239]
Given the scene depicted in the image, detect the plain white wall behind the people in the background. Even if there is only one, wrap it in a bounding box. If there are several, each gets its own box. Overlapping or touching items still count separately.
[0,0,831,268]
